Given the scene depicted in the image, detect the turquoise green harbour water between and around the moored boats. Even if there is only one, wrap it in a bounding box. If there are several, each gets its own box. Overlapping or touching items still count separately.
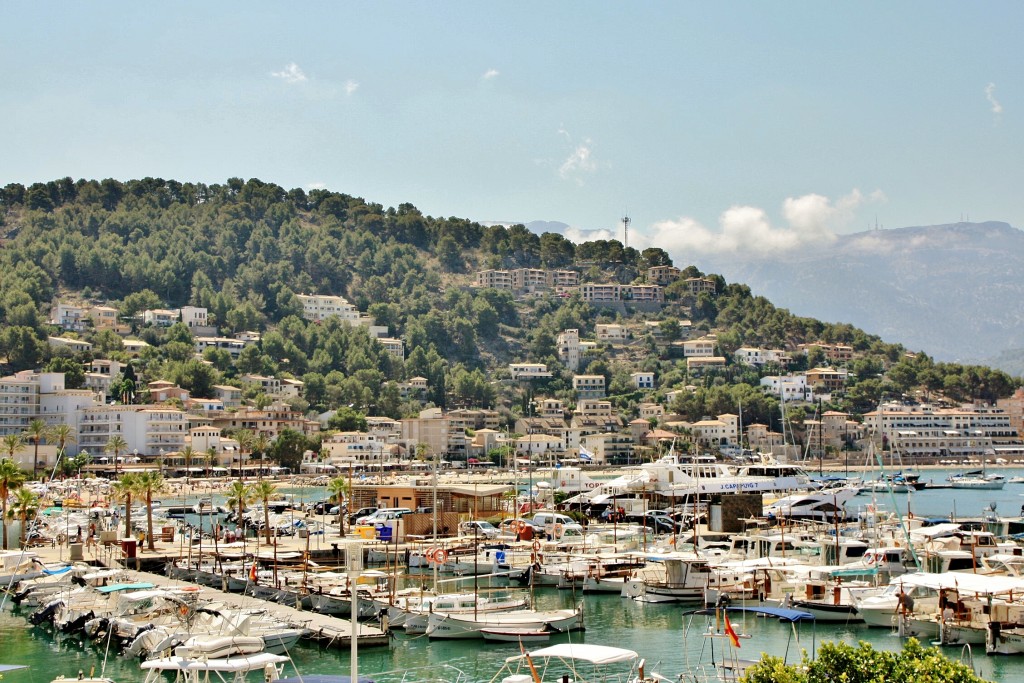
[6,470,1024,683]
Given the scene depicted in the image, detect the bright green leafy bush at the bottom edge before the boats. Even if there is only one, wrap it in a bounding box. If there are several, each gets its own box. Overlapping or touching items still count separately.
[742,638,984,683]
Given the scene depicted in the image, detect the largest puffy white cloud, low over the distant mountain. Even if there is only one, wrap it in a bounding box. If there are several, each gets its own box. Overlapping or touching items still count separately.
[647,189,885,256]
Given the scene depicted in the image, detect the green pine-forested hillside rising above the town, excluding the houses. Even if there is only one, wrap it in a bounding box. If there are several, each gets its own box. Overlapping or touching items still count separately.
[0,178,1017,432]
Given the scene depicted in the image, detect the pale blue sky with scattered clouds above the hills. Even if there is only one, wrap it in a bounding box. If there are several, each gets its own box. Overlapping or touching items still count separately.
[0,0,1024,262]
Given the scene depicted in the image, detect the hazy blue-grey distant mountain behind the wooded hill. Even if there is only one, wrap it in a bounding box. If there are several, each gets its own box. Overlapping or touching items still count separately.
[696,221,1024,373]
